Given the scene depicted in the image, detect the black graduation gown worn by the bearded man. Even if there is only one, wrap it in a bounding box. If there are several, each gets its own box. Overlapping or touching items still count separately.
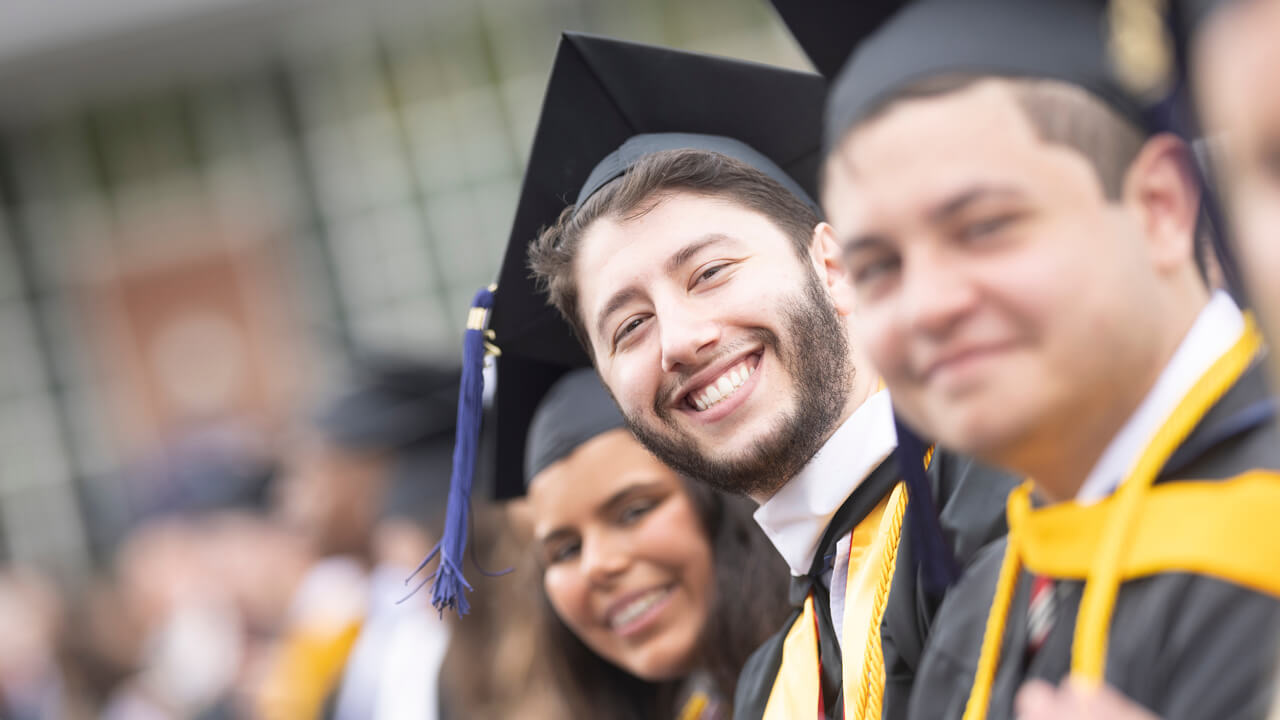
[733,450,1016,720]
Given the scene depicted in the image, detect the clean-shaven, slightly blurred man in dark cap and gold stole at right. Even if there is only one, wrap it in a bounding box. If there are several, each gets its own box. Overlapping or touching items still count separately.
[823,0,1280,720]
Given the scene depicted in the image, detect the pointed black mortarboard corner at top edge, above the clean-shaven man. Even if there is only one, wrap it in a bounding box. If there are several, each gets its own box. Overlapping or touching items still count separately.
[769,0,904,78]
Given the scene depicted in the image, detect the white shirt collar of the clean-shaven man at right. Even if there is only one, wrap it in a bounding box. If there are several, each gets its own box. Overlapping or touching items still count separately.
[1075,291,1244,503]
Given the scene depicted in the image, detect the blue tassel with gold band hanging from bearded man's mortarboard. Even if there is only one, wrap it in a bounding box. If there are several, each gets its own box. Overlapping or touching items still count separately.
[406,286,495,618]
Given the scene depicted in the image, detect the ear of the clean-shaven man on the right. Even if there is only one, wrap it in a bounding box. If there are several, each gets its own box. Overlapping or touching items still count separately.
[1123,133,1201,270]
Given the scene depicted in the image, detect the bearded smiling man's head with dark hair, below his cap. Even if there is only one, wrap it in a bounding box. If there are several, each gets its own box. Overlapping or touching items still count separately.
[531,143,870,502]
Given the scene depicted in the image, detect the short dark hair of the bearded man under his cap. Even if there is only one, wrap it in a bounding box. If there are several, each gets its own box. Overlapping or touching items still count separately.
[529,150,822,354]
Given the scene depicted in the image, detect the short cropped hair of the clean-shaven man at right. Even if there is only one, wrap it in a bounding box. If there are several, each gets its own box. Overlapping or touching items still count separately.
[845,73,1147,201]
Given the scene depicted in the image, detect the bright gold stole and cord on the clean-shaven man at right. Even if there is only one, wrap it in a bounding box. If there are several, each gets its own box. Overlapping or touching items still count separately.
[964,318,1280,720]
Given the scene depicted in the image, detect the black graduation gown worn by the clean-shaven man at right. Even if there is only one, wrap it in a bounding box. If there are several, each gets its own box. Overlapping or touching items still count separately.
[910,365,1280,720]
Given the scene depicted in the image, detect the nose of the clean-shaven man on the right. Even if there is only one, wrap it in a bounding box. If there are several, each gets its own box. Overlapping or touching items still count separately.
[900,249,978,337]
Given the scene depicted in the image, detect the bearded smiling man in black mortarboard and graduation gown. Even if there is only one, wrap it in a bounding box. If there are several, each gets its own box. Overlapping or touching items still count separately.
[492,35,1010,717]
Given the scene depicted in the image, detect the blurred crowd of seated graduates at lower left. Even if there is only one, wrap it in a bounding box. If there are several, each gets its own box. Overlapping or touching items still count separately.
[0,361,558,720]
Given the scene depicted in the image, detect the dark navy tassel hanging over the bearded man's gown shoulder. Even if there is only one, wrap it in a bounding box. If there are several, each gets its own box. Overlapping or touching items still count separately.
[893,418,960,598]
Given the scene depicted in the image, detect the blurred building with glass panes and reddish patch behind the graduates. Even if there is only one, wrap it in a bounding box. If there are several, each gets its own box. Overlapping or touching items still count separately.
[0,0,805,579]
